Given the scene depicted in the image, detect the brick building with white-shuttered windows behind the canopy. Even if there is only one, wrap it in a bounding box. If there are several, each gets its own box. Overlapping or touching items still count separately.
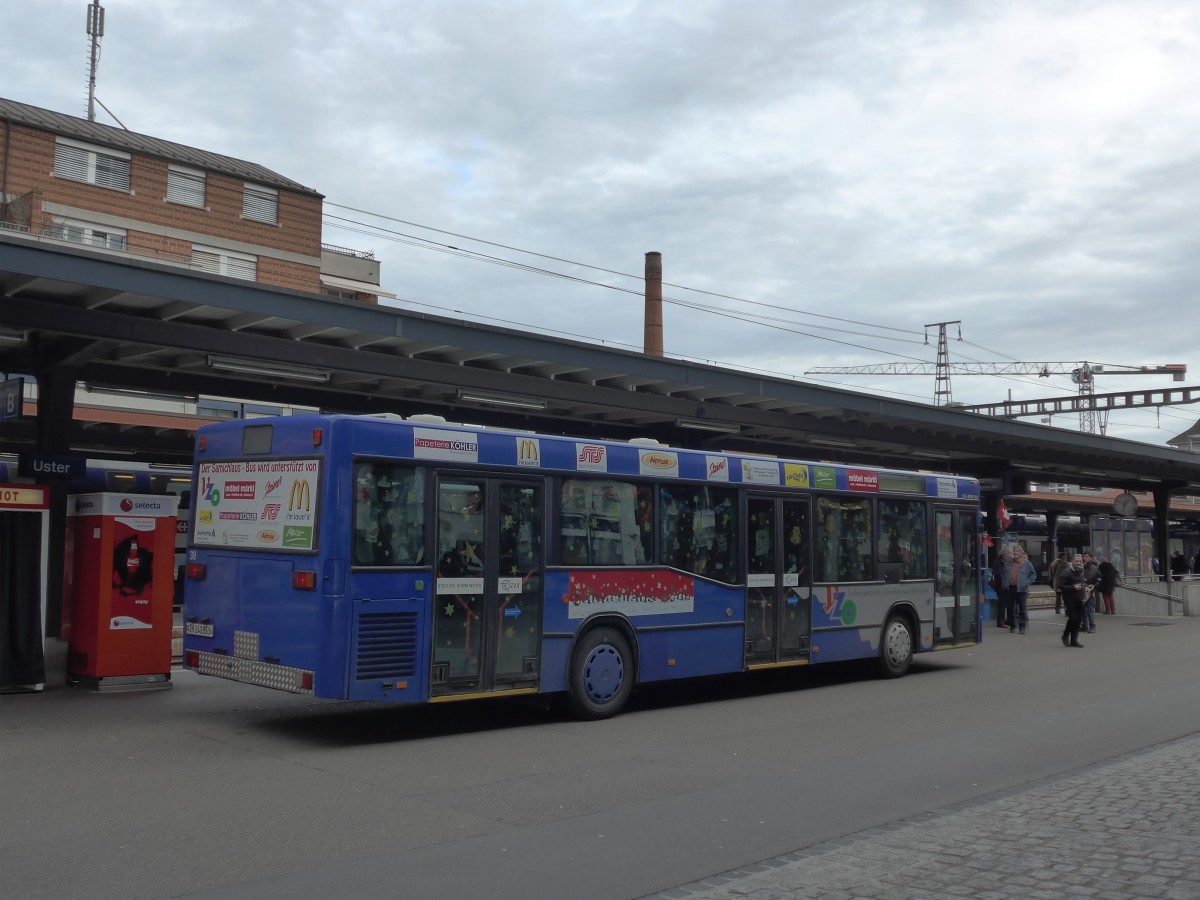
[0,98,328,300]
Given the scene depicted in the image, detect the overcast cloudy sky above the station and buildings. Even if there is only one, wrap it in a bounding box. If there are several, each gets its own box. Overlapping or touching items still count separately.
[0,0,1200,443]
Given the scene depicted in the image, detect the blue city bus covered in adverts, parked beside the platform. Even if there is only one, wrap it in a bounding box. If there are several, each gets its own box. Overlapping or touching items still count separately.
[184,415,982,718]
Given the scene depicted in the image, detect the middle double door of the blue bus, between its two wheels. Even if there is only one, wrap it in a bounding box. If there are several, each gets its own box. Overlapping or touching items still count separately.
[745,494,812,667]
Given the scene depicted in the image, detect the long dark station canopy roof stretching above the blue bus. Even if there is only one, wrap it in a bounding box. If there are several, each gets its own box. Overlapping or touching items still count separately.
[0,233,1200,492]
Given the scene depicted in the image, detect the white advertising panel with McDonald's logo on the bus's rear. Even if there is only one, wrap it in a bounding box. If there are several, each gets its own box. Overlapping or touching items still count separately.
[192,460,320,551]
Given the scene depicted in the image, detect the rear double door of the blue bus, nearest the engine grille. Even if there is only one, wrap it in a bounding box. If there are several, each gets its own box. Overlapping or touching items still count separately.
[430,473,545,698]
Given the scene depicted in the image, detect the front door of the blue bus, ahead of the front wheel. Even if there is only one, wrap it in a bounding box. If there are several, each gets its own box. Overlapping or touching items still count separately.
[934,509,979,644]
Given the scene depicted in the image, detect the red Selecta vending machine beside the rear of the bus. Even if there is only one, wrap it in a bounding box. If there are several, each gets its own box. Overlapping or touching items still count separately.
[64,493,176,691]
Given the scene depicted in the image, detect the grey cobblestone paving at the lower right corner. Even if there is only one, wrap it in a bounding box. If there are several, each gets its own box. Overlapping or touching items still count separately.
[654,736,1200,900]
